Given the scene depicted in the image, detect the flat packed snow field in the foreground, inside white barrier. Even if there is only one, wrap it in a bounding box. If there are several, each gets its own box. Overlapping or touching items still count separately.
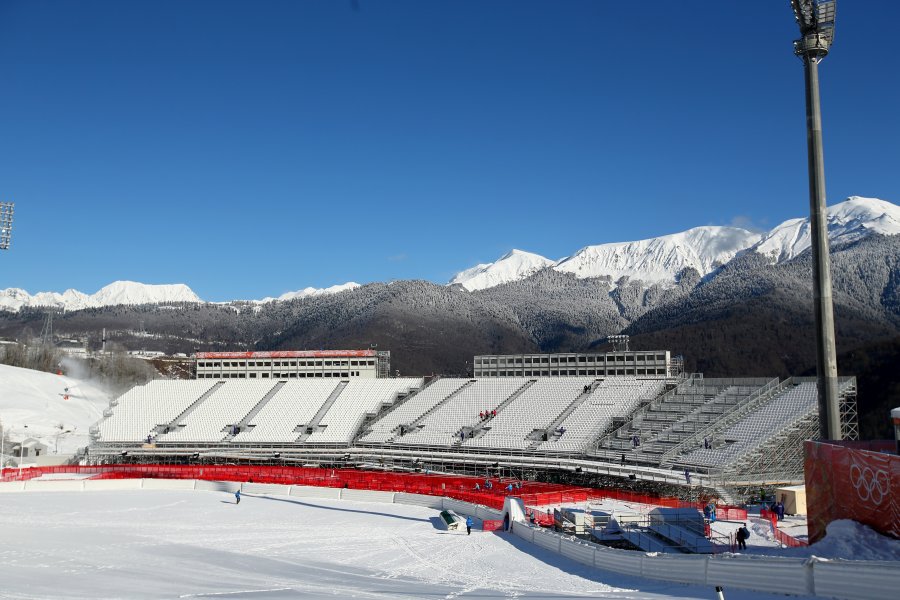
[0,490,824,600]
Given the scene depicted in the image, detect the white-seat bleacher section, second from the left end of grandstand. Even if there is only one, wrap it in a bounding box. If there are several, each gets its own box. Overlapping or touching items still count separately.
[157,380,277,443]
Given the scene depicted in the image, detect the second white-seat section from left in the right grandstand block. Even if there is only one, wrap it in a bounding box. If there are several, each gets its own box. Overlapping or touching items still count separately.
[395,377,531,446]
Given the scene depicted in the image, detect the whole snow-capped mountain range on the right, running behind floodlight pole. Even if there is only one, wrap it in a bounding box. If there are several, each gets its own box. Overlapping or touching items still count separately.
[450,196,900,290]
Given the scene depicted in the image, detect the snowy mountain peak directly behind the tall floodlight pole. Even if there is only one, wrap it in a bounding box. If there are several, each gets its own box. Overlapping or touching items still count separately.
[753,196,900,263]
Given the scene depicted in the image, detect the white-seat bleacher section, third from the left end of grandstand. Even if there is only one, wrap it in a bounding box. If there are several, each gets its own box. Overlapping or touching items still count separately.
[229,379,339,443]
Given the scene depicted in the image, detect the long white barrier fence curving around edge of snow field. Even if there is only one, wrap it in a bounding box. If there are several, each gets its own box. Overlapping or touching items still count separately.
[0,479,900,600]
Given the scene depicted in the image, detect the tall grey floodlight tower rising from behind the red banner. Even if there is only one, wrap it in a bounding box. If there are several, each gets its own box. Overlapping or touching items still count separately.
[791,0,841,440]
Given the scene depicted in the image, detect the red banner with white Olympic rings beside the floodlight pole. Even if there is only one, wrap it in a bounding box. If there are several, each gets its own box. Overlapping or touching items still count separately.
[804,441,900,543]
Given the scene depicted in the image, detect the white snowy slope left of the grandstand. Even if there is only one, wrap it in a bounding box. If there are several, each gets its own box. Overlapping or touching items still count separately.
[0,365,110,460]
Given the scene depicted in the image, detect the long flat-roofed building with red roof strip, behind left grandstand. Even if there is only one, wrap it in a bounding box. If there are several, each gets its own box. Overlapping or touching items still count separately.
[196,350,391,380]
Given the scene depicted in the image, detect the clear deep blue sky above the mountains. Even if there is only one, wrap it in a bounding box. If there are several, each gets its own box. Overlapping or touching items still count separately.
[0,0,900,301]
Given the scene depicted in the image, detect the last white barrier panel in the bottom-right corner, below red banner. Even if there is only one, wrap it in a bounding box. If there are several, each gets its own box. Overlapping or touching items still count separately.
[812,560,900,600]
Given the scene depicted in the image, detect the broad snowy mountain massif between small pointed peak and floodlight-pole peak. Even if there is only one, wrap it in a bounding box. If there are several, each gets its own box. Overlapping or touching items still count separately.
[554,226,761,283]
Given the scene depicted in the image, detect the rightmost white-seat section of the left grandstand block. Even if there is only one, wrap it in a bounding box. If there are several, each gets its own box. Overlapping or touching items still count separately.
[306,377,422,443]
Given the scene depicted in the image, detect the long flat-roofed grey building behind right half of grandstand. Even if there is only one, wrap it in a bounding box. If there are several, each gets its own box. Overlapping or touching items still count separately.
[473,350,680,377]
